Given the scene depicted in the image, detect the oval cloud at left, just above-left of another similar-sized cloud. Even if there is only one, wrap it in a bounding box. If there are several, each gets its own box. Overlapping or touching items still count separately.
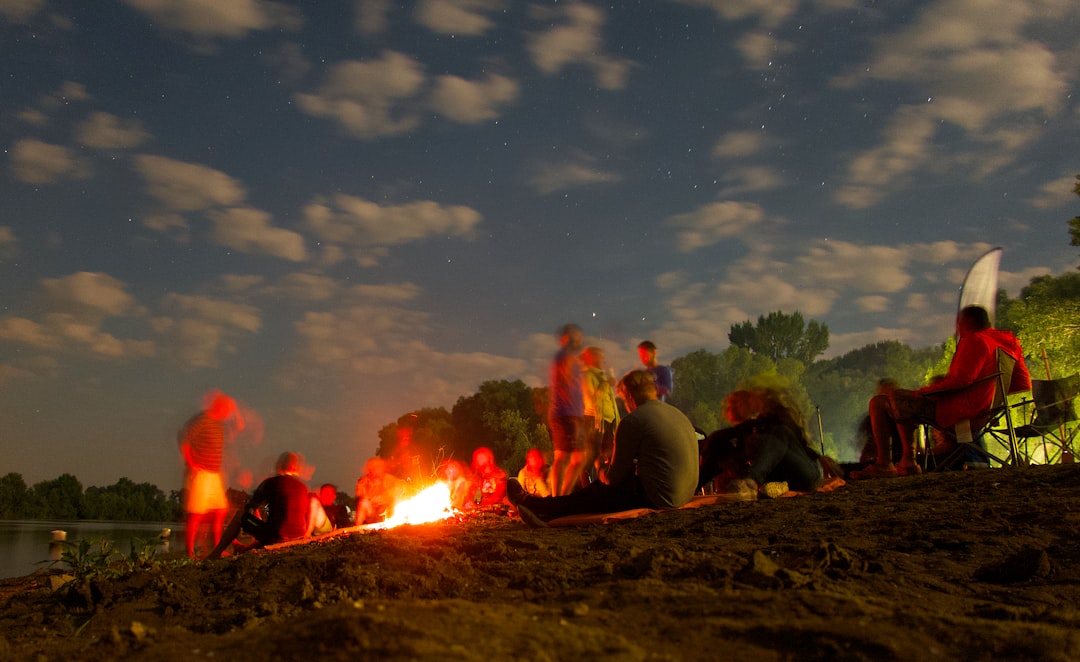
[135,154,247,212]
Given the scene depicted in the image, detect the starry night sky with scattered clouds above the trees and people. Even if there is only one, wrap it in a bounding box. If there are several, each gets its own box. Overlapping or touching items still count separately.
[0,0,1080,491]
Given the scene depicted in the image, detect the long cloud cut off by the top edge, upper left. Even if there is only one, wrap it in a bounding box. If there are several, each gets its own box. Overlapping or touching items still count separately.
[124,0,300,39]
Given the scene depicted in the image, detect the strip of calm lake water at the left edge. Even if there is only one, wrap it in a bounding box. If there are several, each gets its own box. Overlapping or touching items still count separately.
[0,519,184,579]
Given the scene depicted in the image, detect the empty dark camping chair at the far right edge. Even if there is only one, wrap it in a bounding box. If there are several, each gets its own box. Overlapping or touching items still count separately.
[1016,375,1080,464]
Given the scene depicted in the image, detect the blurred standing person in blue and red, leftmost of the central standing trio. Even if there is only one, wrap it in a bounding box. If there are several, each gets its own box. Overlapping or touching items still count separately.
[548,324,585,496]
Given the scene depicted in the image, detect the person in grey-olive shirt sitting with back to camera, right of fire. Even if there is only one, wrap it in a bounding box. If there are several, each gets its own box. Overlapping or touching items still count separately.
[507,370,698,526]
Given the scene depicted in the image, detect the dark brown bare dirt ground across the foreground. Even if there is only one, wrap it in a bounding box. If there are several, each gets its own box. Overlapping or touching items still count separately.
[0,464,1080,661]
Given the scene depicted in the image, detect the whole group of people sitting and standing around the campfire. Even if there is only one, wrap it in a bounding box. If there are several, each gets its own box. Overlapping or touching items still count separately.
[180,307,1030,544]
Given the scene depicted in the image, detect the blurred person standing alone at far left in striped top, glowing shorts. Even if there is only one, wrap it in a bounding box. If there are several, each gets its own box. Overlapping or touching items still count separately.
[177,389,244,558]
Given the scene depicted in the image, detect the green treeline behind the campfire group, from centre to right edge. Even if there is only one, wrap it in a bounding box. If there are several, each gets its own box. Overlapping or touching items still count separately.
[377,272,1080,473]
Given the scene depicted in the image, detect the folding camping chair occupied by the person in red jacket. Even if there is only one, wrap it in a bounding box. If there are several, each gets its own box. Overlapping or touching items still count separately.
[922,349,1022,470]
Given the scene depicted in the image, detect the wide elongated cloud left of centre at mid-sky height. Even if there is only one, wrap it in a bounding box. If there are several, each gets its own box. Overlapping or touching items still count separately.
[303,194,482,262]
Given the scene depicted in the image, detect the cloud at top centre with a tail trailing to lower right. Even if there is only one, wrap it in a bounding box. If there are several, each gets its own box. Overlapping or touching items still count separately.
[526,2,631,90]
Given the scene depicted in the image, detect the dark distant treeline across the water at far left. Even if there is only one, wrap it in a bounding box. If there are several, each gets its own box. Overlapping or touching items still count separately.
[0,473,183,522]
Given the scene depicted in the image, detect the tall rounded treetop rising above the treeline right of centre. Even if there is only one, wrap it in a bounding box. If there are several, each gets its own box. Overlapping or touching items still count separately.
[728,310,828,364]
